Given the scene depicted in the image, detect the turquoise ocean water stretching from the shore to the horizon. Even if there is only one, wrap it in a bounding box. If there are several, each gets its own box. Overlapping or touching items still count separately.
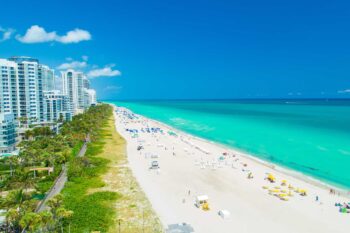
[110,100,350,188]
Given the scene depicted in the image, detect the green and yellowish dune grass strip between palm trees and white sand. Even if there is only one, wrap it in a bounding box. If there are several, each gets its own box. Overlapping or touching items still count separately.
[63,112,163,233]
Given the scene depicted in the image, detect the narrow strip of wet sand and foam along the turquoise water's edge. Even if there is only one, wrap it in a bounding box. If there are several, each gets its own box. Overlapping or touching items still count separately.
[117,104,350,198]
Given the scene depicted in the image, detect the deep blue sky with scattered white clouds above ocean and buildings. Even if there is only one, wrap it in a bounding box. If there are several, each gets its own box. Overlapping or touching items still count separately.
[0,0,350,100]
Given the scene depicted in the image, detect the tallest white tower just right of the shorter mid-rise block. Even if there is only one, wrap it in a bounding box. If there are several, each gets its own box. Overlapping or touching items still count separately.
[62,69,88,114]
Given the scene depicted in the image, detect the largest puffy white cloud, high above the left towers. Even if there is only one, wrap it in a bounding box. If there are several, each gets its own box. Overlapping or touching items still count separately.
[16,25,91,44]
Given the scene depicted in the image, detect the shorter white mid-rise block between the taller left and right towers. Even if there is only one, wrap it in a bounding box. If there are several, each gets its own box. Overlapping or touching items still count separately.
[44,90,72,122]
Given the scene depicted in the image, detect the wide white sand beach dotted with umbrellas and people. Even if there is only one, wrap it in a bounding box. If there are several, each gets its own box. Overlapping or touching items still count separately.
[114,108,350,233]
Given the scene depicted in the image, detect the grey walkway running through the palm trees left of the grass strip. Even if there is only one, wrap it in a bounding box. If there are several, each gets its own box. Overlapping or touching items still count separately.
[35,135,90,212]
